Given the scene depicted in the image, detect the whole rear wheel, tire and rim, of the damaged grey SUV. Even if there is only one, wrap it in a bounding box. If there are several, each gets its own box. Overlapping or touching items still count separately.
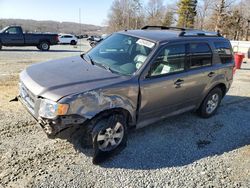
[198,87,222,118]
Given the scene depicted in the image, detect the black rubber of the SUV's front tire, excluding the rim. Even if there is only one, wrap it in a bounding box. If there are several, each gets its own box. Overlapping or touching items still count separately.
[92,114,127,164]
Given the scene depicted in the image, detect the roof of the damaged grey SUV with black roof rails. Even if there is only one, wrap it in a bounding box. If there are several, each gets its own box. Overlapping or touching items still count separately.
[119,26,224,42]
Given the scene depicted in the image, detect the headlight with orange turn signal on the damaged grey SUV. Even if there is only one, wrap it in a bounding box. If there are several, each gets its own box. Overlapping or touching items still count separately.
[39,99,69,118]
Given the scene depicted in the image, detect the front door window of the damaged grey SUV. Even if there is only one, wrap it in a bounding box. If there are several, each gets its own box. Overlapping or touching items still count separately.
[150,44,186,76]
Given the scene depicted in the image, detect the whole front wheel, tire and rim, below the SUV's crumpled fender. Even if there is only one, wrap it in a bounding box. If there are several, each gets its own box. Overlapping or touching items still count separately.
[92,114,127,164]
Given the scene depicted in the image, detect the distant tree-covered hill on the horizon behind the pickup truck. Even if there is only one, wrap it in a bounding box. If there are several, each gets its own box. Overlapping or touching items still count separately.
[0,19,104,34]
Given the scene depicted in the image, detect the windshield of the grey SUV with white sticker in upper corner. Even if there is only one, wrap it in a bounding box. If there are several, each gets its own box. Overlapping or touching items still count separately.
[84,33,155,75]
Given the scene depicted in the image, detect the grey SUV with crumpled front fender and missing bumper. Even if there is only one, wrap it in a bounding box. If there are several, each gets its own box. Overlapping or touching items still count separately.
[19,26,234,162]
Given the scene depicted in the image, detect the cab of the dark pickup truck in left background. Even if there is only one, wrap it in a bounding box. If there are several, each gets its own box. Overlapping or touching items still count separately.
[2,27,24,46]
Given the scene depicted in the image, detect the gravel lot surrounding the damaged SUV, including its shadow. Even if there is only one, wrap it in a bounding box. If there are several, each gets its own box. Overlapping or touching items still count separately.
[0,42,250,187]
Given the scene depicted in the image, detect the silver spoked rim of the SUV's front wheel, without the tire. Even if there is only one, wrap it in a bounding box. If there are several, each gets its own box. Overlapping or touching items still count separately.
[97,122,124,151]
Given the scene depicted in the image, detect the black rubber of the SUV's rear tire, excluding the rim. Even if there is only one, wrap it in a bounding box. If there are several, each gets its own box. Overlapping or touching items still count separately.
[199,87,222,118]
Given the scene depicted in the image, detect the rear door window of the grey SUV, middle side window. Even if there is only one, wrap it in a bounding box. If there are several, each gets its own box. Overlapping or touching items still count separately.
[189,43,212,69]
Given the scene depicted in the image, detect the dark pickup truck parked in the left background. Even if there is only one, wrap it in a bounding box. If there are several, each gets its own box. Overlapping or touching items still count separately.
[0,26,59,51]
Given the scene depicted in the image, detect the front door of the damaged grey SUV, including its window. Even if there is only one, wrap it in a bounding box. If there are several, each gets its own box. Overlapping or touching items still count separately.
[138,44,191,126]
